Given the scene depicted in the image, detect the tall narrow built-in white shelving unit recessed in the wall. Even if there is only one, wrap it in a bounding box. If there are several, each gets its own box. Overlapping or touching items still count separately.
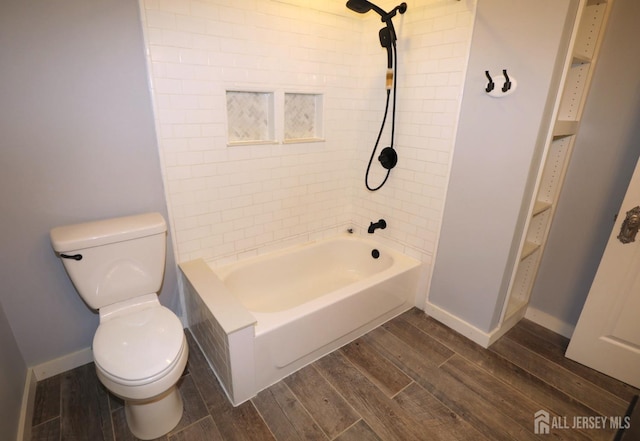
[501,0,614,330]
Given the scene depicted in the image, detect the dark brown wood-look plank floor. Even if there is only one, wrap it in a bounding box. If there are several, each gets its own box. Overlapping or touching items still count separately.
[32,309,638,441]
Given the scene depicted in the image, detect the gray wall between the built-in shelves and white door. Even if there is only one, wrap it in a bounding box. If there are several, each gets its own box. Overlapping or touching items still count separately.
[530,0,640,326]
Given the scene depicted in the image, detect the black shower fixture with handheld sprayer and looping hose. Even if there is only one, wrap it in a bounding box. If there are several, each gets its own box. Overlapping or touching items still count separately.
[347,0,407,191]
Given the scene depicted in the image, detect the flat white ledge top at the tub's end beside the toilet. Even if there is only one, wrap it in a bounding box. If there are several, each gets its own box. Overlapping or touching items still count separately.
[178,259,257,334]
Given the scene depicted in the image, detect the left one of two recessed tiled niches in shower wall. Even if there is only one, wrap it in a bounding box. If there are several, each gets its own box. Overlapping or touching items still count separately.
[227,91,275,144]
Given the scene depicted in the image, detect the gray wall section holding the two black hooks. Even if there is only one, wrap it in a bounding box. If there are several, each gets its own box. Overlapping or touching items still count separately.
[429,0,577,331]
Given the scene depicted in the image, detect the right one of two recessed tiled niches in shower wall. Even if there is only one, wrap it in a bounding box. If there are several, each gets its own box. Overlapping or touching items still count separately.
[284,93,323,142]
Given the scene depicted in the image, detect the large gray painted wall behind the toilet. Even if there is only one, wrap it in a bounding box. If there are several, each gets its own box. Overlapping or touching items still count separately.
[0,0,178,366]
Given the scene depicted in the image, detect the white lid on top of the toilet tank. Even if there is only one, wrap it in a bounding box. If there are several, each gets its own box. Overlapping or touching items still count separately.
[49,213,167,253]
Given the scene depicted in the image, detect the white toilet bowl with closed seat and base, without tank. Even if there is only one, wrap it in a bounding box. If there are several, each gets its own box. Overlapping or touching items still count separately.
[93,294,189,440]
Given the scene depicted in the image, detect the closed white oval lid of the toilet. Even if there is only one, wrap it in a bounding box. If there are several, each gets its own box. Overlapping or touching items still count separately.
[93,306,184,381]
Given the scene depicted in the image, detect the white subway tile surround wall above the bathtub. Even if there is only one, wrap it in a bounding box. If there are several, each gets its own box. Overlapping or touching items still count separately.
[141,0,475,264]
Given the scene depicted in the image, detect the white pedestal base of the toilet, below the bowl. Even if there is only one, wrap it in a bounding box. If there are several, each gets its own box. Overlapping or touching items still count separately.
[124,380,184,440]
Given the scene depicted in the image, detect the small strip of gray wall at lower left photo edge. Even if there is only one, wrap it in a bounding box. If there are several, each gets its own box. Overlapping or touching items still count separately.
[0,303,27,440]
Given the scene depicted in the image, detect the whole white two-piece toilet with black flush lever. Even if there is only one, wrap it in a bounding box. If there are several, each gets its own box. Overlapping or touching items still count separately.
[50,213,189,440]
